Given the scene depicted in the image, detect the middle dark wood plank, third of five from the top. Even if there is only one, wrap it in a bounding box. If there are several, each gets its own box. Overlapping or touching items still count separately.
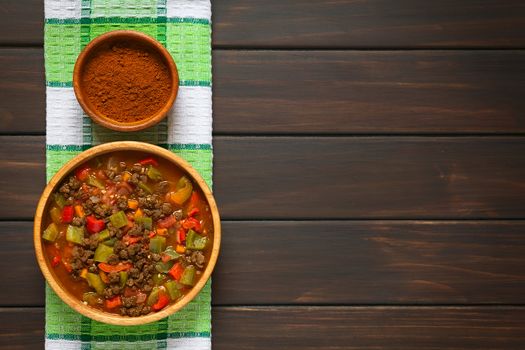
[0,136,525,220]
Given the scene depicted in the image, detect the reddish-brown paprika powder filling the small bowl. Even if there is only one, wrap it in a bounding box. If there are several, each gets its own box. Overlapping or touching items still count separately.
[82,42,172,124]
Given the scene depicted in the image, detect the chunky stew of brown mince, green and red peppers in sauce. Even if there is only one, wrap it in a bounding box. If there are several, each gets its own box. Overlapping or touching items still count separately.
[42,152,213,316]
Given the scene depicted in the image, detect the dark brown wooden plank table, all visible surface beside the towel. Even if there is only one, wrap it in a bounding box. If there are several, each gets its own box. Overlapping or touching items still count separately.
[0,0,525,349]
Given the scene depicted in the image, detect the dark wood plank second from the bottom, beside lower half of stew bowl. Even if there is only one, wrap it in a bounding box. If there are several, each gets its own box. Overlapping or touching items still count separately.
[4,221,525,306]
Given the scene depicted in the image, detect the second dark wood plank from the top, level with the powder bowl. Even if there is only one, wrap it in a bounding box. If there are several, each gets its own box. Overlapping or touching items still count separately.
[0,49,525,134]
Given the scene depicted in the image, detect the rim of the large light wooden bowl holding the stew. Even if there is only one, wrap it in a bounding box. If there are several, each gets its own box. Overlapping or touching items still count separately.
[33,141,221,326]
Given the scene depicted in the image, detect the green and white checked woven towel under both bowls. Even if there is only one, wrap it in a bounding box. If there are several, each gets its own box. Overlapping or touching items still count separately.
[44,0,212,350]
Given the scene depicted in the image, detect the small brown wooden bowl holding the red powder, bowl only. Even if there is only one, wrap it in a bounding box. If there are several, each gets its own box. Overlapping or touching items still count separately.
[73,30,179,131]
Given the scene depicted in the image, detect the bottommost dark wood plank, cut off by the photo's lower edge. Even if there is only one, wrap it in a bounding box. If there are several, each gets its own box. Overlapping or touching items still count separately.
[0,307,525,350]
